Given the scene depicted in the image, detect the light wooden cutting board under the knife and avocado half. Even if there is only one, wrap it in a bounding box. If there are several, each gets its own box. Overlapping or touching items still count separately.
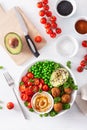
[0,5,46,65]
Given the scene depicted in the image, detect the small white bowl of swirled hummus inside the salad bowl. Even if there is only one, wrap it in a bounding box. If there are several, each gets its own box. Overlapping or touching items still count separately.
[31,91,54,114]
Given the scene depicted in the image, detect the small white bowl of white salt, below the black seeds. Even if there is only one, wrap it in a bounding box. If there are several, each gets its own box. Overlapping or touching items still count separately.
[56,35,79,58]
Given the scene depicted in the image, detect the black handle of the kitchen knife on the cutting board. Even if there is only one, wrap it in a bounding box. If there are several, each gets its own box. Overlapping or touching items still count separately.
[25,35,40,57]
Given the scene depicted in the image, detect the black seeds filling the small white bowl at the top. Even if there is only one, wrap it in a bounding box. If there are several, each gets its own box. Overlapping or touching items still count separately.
[57,0,73,16]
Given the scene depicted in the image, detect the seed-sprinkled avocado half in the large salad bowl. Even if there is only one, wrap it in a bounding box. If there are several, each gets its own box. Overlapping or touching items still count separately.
[50,68,69,87]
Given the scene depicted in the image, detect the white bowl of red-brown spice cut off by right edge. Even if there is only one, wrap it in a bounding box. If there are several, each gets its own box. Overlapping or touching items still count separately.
[74,17,87,35]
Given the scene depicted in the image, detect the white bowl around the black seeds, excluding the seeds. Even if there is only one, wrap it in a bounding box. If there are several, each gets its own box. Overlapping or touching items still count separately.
[55,0,76,18]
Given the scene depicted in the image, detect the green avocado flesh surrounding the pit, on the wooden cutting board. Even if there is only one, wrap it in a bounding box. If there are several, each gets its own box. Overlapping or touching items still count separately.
[4,32,23,55]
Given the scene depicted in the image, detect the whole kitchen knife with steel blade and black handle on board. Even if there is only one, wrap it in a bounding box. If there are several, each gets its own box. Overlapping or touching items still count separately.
[14,7,40,57]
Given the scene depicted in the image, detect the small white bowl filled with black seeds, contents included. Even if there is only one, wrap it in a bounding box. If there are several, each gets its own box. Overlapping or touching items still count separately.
[56,0,76,18]
